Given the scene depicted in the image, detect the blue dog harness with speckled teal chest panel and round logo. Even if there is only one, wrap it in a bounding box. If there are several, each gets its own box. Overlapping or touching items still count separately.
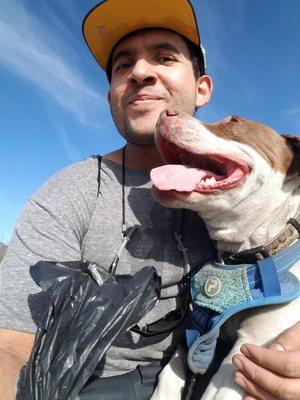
[187,240,300,374]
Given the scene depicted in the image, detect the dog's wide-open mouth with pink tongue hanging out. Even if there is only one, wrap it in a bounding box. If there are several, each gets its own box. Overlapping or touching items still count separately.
[151,137,250,194]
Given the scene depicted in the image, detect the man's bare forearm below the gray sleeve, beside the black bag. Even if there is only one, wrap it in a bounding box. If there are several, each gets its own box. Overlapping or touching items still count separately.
[0,328,34,400]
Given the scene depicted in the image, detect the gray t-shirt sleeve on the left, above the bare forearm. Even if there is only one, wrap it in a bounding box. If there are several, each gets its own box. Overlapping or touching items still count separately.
[0,158,98,333]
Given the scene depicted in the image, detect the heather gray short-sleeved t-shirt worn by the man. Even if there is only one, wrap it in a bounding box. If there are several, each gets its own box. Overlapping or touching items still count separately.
[0,158,213,376]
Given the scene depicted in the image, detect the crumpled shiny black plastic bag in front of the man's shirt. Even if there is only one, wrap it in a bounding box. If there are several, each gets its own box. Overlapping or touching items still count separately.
[17,261,160,400]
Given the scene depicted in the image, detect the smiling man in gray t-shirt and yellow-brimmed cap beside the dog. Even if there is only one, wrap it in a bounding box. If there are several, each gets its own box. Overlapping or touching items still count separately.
[0,0,300,400]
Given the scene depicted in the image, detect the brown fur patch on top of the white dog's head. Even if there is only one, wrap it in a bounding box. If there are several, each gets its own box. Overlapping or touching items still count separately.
[204,115,300,174]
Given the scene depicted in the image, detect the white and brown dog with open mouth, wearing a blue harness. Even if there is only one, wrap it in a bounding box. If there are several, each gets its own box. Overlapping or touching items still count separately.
[151,110,300,400]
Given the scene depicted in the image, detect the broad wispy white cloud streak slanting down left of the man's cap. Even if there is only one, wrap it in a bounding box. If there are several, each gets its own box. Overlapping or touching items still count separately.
[0,1,106,125]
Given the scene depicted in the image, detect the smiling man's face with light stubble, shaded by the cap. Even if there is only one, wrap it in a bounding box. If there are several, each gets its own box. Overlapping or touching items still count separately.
[109,29,209,145]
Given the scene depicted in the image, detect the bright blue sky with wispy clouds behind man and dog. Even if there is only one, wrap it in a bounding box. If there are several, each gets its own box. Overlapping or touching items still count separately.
[0,0,300,242]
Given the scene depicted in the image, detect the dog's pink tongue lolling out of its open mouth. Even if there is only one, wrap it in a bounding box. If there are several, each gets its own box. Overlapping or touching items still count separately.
[150,165,206,192]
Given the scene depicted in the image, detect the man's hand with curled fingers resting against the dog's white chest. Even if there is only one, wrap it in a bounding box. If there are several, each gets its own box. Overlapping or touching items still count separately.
[233,322,300,400]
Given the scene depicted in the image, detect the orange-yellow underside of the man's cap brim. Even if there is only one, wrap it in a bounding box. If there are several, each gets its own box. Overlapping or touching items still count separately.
[82,0,200,70]
